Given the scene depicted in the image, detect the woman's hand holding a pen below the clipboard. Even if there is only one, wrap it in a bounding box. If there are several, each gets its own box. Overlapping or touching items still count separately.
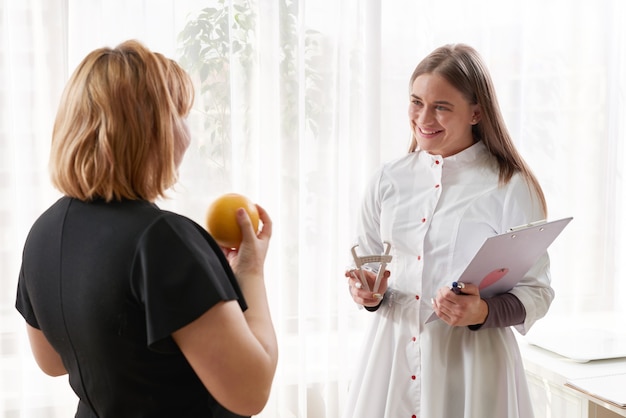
[433,284,489,327]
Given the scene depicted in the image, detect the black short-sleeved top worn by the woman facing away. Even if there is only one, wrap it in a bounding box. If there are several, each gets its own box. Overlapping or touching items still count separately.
[16,197,247,418]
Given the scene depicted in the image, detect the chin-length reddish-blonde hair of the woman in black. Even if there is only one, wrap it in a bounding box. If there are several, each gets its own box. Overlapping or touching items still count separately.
[50,40,194,201]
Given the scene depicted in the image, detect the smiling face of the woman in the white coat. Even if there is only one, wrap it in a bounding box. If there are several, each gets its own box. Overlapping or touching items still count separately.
[409,73,480,157]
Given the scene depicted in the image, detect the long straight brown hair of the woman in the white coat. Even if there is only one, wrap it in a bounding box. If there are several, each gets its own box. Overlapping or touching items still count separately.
[409,44,547,215]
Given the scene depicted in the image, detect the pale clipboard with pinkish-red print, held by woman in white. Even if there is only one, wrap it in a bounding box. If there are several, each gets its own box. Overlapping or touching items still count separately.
[426,217,573,323]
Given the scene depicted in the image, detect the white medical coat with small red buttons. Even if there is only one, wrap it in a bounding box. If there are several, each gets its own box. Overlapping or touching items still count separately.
[344,142,554,418]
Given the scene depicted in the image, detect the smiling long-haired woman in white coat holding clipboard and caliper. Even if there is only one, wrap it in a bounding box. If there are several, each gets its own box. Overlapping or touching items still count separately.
[344,44,554,418]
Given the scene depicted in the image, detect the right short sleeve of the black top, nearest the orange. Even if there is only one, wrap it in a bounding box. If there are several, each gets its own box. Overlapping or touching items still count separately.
[131,212,246,351]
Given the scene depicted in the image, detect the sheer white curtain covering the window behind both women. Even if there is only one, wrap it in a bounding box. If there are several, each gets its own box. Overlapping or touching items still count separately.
[0,0,626,418]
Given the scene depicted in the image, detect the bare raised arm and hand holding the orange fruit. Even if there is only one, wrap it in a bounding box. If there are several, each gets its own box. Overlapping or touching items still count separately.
[172,207,278,415]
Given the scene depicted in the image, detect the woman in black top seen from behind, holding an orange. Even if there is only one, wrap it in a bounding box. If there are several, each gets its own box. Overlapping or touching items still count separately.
[16,41,277,418]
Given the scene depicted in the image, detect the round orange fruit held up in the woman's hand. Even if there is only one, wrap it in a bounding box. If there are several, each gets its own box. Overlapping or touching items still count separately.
[206,193,259,248]
